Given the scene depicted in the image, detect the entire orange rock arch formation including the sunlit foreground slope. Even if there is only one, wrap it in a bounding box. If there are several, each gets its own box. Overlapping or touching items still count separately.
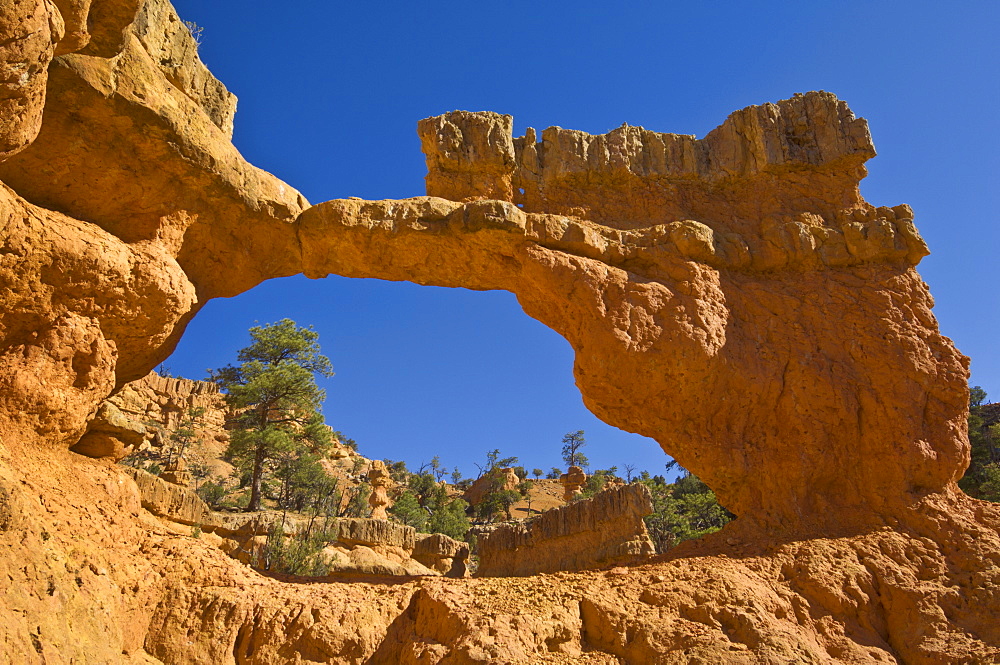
[0,0,1000,664]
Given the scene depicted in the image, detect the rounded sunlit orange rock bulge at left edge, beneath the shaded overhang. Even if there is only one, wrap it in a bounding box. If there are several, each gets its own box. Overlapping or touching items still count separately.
[0,186,196,447]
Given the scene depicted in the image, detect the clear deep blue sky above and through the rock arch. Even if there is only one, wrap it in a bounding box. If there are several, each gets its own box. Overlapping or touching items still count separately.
[167,0,1000,482]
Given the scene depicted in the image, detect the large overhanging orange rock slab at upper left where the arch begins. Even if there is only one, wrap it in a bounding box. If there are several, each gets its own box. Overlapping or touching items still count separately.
[0,3,305,338]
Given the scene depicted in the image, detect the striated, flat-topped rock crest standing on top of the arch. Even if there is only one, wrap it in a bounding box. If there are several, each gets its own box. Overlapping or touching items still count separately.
[417,93,875,232]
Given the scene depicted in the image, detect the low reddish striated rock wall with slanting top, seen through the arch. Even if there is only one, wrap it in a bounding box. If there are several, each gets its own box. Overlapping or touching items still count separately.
[477,483,655,577]
